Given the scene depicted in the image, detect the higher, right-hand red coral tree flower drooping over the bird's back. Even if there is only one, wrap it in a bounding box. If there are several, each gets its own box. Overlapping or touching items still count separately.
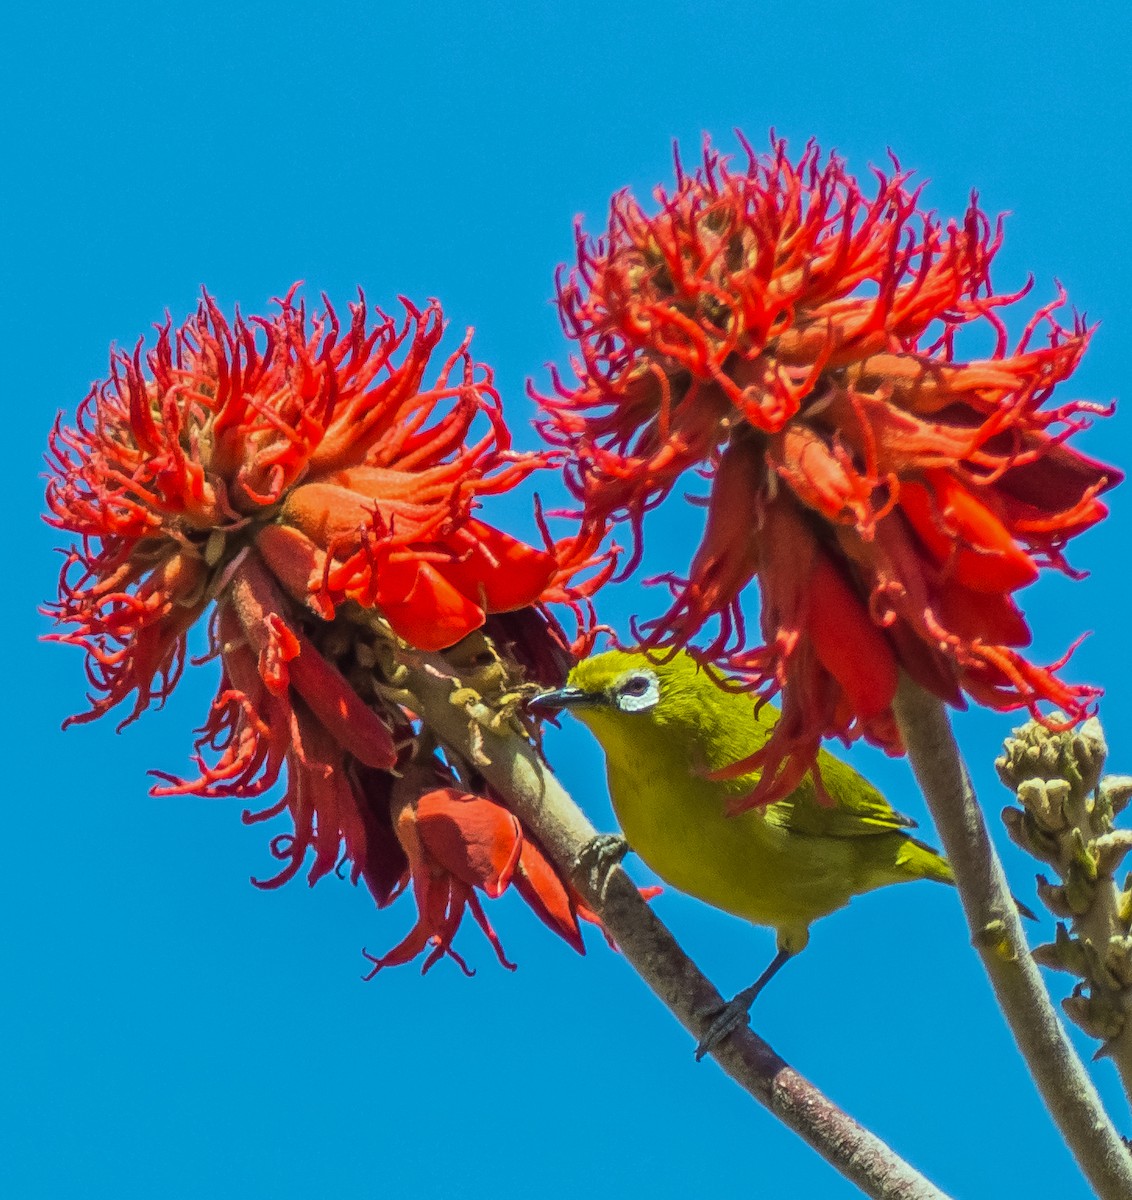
[540,133,1121,803]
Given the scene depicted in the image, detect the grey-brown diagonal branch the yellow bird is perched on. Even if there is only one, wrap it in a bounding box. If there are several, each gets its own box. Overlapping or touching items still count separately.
[405,656,946,1200]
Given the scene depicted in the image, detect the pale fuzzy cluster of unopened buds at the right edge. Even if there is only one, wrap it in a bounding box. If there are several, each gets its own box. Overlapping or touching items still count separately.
[995,714,1132,1057]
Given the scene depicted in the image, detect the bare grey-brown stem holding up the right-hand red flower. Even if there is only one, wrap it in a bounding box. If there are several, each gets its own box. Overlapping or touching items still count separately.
[894,677,1132,1200]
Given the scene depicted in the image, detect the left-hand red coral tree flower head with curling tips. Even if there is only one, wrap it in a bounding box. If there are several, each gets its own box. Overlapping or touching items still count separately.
[47,289,610,969]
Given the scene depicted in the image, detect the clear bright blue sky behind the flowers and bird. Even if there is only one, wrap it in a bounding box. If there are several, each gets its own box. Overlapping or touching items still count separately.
[8,0,1132,1200]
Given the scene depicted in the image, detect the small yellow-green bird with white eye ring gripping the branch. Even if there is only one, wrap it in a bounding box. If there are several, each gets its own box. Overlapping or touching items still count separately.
[533,650,954,1057]
